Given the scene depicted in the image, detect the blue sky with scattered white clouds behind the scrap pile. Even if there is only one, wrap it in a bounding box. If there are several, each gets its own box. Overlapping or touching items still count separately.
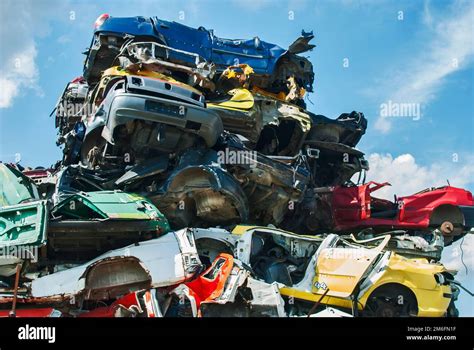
[0,0,474,316]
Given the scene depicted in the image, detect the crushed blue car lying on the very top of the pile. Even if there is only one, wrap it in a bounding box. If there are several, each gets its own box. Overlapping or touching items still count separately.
[84,14,315,92]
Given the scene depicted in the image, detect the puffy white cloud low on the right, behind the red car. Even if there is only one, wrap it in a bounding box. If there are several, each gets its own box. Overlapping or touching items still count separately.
[367,153,474,316]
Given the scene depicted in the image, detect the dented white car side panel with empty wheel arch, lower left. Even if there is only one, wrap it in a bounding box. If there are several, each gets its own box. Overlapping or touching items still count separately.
[31,229,201,298]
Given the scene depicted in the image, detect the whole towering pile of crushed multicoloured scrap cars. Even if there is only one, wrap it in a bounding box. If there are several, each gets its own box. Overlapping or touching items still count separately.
[0,15,474,317]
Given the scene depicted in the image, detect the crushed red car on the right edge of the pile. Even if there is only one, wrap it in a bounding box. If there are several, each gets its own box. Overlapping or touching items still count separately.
[318,181,474,241]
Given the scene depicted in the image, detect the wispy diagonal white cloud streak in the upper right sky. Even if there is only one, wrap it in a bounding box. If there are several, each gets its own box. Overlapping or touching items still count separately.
[375,2,474,133]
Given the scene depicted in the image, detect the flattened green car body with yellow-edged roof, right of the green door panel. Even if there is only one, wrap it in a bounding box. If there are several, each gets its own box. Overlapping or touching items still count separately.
[48,191,170,262]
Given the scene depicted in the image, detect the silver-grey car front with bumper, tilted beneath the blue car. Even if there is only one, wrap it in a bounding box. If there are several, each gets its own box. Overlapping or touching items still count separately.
[75,68,222,167]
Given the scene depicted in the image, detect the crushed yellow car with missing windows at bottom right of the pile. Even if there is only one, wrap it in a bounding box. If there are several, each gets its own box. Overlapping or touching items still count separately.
[198,226,459,317]
